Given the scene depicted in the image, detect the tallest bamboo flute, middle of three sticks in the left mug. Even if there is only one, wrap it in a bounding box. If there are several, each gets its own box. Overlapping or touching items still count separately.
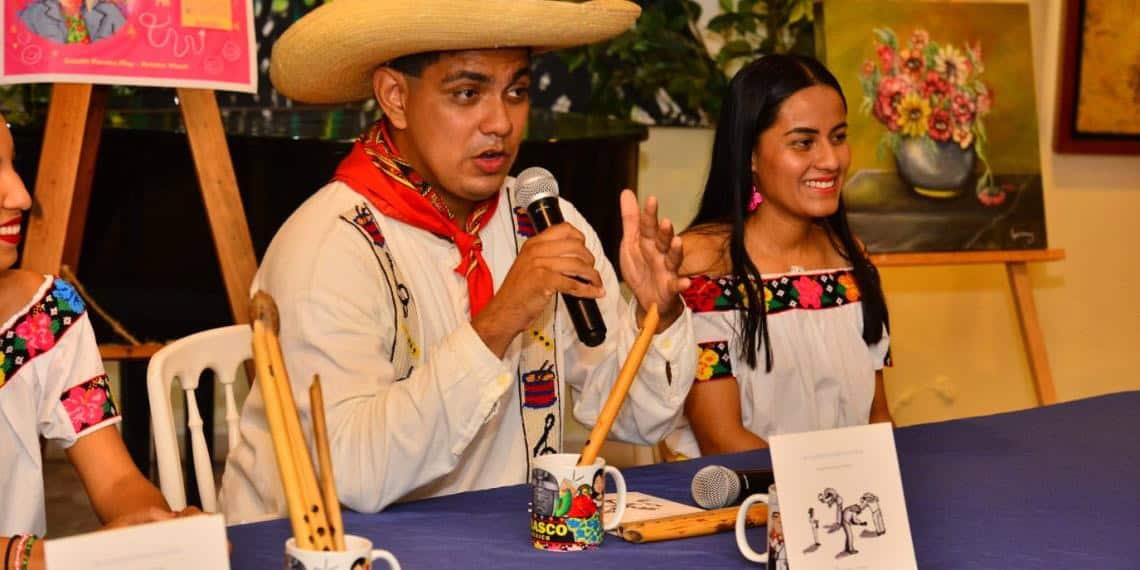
[262,292,334,551]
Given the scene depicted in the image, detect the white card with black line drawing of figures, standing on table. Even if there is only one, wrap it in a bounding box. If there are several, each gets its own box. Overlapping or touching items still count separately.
[754,423,918,570]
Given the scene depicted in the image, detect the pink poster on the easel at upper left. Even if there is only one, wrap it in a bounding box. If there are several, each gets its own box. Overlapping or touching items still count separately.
[0,0,258,92]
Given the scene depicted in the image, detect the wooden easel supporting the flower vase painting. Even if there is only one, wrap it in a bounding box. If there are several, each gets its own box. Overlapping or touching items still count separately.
[871,250,1065,406]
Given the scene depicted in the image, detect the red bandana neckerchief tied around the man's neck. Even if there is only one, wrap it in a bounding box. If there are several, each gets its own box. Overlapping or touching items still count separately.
[333,119,499,317]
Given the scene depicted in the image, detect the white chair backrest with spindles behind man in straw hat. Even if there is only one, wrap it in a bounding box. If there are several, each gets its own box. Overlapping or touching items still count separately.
[146,325,252,513]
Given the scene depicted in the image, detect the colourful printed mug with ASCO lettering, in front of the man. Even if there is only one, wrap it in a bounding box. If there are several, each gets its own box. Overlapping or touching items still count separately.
[530,454,626,552]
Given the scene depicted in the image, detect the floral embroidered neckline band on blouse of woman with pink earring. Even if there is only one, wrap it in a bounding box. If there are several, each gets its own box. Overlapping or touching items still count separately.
[682,269,861,315]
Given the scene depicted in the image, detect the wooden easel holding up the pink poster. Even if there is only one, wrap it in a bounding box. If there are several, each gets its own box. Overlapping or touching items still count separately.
[23,83,257,360]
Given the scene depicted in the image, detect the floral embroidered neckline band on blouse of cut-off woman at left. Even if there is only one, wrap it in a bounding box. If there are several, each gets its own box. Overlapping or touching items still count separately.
[0,279,84,386]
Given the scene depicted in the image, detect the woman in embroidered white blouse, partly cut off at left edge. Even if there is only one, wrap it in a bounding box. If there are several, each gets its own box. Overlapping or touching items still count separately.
[0,115,174,569]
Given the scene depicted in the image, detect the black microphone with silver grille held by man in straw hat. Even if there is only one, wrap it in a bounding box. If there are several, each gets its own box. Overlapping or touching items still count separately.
[514,166,605,347]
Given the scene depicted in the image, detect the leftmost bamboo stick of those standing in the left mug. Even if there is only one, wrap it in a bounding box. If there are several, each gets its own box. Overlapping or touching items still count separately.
[250,319,307,549]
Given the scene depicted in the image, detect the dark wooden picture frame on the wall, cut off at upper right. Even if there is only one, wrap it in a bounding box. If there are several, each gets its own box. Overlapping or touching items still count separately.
[1053,0,1140,154]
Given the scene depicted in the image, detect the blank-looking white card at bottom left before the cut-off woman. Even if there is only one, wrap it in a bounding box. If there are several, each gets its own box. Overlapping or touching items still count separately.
[43,514,229,570]
